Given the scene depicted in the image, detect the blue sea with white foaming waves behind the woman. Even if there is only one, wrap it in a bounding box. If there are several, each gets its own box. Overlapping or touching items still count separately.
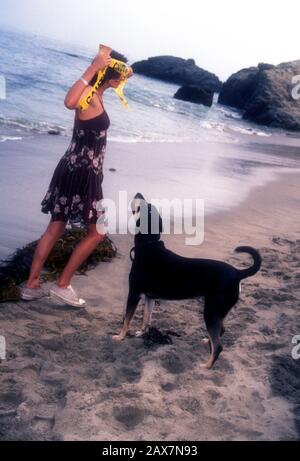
[0,29,292,143]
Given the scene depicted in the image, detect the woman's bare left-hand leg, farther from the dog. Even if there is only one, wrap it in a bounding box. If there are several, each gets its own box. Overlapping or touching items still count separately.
[25,218,66,288]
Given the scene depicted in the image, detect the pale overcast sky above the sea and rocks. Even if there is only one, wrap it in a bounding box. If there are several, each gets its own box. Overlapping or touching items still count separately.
[0,0,300,80]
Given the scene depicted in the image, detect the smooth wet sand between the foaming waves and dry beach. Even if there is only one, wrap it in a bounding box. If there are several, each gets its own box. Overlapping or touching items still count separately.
[0,127,300,259]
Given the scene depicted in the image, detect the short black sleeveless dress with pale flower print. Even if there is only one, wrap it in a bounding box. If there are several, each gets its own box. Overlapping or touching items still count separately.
[41,104,110,225]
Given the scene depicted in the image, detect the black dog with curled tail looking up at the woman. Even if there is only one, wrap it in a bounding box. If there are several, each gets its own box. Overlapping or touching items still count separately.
[113,193,261,368]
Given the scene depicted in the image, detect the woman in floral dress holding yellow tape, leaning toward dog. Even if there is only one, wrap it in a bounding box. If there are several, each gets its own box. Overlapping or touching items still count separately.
[21,47,132,306]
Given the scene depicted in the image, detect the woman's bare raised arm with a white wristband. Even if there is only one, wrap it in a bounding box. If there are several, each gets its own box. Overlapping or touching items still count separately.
[64,53,111,109]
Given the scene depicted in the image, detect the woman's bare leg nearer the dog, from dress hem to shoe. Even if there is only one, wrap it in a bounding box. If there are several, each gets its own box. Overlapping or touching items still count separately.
[56,224,105,288]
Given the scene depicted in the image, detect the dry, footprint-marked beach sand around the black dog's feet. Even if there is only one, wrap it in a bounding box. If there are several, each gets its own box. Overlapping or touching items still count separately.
[0,168,300,441]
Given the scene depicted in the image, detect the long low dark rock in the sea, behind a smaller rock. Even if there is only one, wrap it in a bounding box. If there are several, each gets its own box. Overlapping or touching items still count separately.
[132,56,222,93]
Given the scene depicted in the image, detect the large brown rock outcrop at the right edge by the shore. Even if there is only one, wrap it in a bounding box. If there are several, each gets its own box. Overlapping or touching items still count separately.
[218,60,300,131]
